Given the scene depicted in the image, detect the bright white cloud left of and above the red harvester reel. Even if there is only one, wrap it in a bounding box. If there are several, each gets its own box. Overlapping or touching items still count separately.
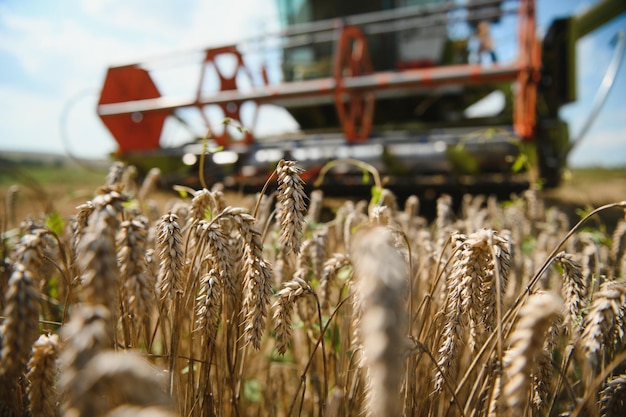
[0,0,275,156]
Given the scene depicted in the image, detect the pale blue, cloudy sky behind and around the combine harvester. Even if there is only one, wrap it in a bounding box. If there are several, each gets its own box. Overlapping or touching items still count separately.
[0,0,626,167]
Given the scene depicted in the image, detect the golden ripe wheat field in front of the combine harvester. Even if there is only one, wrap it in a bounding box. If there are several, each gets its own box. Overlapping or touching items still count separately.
[0,161,626,417]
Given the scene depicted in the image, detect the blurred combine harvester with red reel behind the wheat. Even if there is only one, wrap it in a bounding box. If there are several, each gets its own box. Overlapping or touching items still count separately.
[97,0,626,194]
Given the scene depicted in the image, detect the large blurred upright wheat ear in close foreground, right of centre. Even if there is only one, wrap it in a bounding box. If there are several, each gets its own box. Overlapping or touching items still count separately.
[351,226,408,416]
